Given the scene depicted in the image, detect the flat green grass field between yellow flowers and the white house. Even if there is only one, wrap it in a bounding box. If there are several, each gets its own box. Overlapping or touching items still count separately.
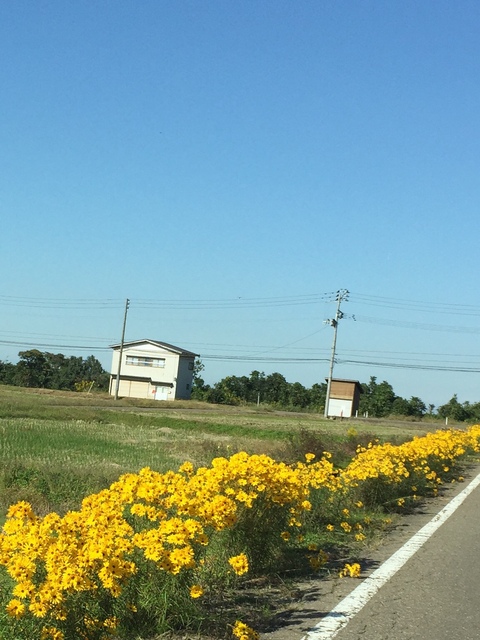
[0,386,438,517]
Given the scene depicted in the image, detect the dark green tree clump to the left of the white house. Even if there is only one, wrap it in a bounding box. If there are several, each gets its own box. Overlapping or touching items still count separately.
[0,349,110,391]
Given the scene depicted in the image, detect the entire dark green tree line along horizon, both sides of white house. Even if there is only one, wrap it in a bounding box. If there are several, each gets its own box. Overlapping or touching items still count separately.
[0,349,480,422]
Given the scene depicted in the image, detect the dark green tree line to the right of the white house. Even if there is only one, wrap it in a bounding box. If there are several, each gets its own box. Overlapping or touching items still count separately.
[192,361,480,421]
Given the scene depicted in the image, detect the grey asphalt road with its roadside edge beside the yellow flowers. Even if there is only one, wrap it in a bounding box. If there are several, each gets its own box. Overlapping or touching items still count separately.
[263,468,480,640]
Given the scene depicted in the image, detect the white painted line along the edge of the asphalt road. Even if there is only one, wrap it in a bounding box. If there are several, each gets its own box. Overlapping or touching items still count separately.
[302,473,480,640]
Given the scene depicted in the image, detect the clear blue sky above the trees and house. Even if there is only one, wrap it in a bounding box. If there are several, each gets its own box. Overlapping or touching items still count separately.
[0,0,480,405]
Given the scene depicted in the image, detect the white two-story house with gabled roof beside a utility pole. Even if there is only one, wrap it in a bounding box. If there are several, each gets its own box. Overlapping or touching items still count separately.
[110,340,197,400]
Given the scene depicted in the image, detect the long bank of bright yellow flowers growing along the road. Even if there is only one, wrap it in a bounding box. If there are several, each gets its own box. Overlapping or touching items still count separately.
[0,426,480,640]
